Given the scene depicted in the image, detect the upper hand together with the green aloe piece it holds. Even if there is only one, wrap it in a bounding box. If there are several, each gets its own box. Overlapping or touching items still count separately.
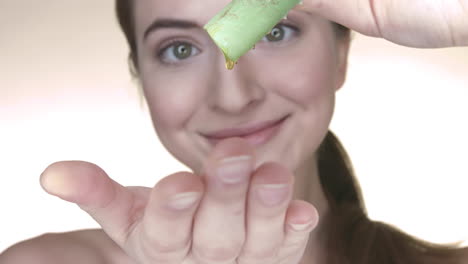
[205,0,468,61]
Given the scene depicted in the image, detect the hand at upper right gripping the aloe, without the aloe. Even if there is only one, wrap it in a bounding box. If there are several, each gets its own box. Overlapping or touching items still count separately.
[297,0,468,48]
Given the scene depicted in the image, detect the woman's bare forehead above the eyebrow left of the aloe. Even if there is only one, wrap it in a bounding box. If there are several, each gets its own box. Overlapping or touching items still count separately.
[134,0,230,30]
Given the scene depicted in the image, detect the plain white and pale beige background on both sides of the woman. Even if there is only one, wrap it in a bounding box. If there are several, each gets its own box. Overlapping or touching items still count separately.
[0,0,468,251]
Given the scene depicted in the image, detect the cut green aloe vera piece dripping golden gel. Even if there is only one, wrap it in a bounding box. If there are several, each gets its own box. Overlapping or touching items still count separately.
[204,0,302,69]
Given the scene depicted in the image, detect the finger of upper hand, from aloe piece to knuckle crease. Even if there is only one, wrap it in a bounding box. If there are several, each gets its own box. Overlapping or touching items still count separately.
[293,0,381,37]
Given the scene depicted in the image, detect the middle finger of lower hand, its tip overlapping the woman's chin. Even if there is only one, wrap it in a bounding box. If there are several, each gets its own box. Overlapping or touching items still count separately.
[192,138,254,263]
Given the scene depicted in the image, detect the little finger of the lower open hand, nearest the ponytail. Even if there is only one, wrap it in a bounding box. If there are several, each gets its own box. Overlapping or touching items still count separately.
[279,200,319,263]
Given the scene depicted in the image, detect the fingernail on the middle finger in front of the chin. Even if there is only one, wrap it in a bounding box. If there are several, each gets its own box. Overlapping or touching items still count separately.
[217,155,252,184]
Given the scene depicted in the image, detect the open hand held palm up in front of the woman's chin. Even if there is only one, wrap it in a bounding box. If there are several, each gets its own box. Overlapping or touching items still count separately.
[41,139,318,264]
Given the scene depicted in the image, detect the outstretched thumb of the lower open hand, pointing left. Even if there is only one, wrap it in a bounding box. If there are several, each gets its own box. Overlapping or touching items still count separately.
[40,161,144,245]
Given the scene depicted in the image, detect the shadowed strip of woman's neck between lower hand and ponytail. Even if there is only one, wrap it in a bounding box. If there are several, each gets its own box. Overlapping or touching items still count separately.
[294,155,329,264]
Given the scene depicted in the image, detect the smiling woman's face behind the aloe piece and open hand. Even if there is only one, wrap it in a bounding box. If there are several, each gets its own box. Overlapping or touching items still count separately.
[134,0,347,172]
